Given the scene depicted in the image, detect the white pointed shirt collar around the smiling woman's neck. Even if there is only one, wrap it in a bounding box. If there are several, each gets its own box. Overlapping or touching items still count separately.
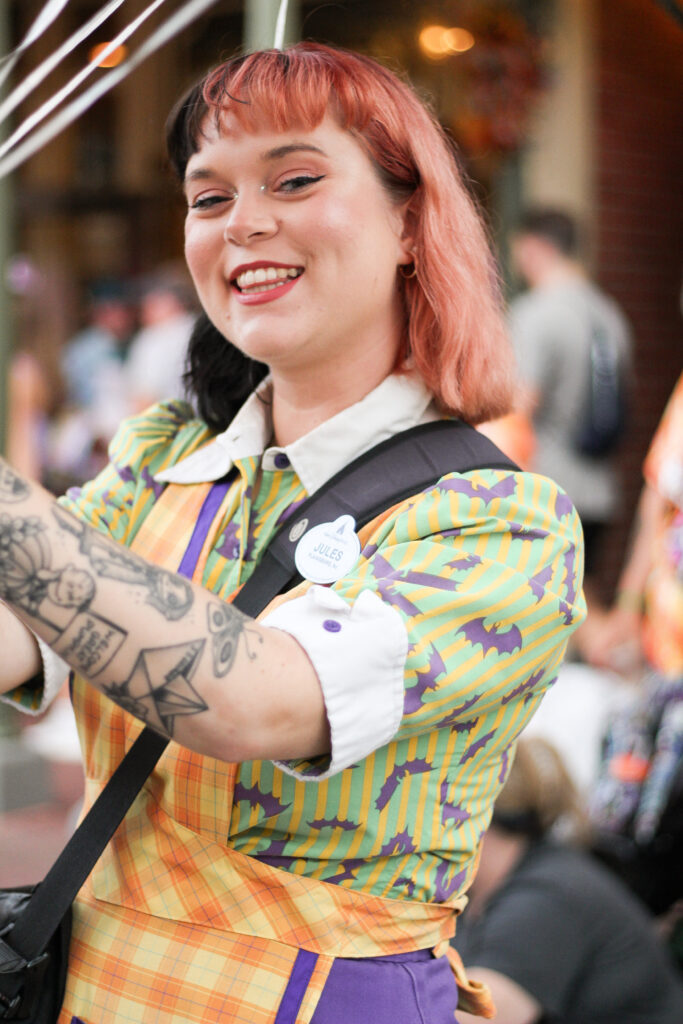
[156,374,439,495]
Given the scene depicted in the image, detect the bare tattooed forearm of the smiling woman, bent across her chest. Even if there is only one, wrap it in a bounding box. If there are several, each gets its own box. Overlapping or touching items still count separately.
[0,460,330,761]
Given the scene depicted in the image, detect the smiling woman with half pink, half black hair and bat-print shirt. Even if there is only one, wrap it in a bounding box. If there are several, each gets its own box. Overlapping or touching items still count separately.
[0,43,584,1024]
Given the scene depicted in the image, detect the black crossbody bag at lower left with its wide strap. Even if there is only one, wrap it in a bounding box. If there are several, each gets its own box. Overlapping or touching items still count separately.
[0,420,517,1024]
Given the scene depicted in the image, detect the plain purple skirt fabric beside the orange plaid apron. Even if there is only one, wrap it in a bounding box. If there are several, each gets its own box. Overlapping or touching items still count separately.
[311,949,458,1024]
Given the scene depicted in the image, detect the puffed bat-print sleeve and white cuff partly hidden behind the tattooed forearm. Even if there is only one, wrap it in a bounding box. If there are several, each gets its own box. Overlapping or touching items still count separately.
[0,401,207,715]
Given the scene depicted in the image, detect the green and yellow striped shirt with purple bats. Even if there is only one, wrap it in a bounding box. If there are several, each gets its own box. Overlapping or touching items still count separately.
[50,380,584,902]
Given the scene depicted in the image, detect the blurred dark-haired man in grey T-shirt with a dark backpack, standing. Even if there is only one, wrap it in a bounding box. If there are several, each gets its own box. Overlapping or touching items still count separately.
[510,207,631,636]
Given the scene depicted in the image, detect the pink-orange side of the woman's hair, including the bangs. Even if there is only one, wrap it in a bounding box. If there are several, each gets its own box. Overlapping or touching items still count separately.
[196,43,515,423]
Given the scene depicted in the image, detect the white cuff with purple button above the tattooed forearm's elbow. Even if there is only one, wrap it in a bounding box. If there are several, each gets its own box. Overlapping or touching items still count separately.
[261,587,409,781]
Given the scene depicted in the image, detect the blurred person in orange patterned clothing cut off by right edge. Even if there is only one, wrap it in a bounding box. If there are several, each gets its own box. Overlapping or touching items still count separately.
[587,374,683,950]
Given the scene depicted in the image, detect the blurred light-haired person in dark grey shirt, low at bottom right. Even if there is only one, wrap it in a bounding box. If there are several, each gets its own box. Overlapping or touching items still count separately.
[454,737,683,1024]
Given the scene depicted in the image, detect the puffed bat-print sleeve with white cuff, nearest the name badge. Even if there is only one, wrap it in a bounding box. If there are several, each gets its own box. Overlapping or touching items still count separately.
[264,470,585,779]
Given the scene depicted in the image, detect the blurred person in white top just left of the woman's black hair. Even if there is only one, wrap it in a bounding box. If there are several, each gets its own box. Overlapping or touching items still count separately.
[126,264,197,413]
